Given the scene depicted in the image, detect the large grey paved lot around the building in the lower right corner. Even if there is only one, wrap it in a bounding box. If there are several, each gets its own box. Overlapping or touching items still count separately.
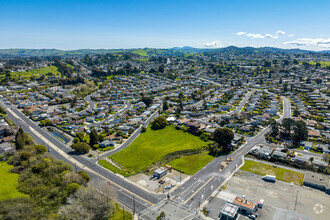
[207,171,330,220]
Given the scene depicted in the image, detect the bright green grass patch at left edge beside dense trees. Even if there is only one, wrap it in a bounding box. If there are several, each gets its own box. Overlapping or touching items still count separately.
[0,162,27,200]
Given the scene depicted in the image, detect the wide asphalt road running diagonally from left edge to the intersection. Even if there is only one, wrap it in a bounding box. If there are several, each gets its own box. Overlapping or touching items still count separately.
[1,102,162,213]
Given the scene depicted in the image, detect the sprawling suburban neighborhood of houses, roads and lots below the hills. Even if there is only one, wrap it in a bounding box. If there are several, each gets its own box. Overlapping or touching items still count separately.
[0,47,330,219]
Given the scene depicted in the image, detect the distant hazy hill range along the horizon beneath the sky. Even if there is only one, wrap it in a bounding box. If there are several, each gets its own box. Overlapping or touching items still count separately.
[0,46,324,57]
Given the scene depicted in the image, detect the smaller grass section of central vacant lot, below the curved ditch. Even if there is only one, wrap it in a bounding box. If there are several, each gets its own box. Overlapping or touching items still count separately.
[169,152,214,175]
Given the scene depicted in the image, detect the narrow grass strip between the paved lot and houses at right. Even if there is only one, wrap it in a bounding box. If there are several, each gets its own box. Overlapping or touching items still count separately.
[241,160,304,185]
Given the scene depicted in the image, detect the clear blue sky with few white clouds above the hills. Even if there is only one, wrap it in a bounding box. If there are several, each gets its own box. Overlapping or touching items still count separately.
[0,0,330,50]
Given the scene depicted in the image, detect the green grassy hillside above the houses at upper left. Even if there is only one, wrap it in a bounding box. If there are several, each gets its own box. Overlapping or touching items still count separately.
[0,66,60,80]
